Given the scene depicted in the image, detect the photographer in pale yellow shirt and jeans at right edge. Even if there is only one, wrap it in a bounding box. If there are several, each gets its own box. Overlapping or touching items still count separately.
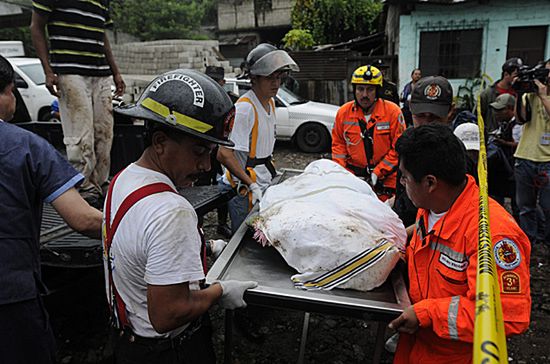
[514,59,550,244]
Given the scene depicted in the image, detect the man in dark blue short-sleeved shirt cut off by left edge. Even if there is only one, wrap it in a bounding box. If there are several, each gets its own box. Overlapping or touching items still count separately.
[0,56,101,364]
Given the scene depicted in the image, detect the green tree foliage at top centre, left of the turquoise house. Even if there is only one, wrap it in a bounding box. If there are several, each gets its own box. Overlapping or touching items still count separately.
[292,0,383,44]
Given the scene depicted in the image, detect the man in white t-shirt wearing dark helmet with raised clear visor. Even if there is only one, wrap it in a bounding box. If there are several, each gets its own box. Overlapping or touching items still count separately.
[218,43,299,233]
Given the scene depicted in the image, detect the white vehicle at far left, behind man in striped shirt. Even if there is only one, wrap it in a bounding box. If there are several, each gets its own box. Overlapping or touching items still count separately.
[8,58,55,121]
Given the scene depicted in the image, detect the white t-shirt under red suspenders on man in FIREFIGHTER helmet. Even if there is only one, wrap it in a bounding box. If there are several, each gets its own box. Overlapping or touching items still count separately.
[104,164,204,338]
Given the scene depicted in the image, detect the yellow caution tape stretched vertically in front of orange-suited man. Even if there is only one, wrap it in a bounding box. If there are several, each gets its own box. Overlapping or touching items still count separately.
[473,75,508,364]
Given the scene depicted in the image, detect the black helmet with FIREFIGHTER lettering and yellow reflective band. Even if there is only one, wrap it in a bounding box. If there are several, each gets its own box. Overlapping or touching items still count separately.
[115,69,235,146]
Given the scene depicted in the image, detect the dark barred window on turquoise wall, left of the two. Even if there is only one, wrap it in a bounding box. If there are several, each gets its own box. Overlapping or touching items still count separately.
[420,29,483,78]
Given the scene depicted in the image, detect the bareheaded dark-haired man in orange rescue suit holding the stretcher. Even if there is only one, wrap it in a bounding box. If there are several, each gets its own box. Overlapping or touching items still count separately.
[389,124,531,364]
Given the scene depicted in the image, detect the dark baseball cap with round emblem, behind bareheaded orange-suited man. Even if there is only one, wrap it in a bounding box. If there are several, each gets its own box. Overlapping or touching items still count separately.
[409,76,453,118]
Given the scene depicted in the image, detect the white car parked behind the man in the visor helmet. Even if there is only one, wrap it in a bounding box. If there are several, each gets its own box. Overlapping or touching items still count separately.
[224,78,339,153]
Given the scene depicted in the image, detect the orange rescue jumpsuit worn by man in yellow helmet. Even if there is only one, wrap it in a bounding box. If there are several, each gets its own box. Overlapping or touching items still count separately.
[332,99,405,198]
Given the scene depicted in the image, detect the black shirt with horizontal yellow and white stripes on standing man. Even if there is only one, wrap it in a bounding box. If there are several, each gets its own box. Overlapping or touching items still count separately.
[33,0,111,76]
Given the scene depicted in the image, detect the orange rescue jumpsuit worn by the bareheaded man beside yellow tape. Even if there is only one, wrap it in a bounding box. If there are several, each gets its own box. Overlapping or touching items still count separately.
[394,176,531,364]
